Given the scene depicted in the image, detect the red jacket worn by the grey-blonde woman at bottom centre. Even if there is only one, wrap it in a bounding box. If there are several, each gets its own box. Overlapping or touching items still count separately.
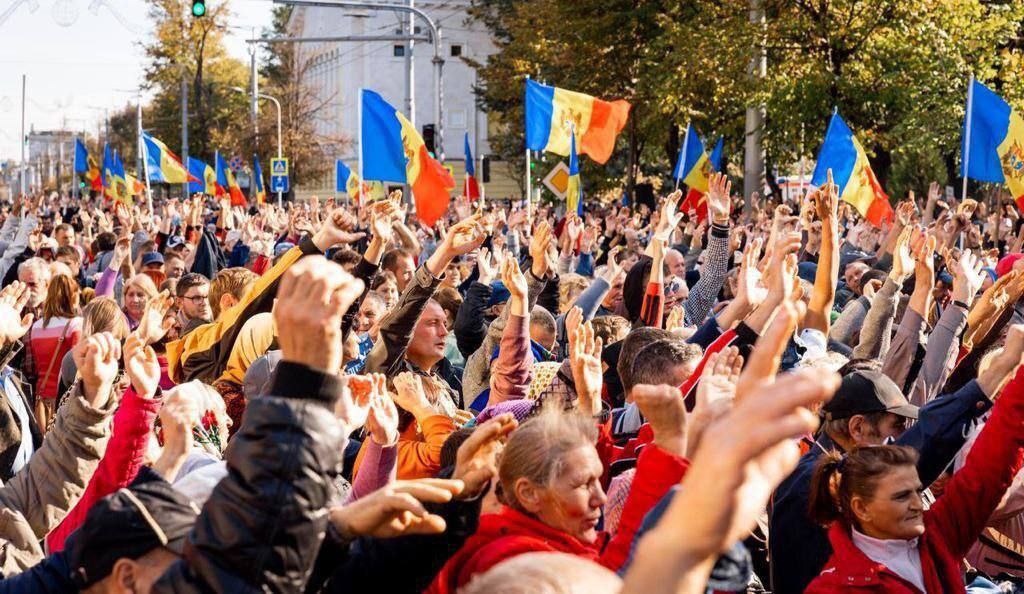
[426,446,689,594]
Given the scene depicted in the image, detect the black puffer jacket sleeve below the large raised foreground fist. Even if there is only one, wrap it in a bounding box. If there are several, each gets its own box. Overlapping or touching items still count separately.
[153,360,345,593]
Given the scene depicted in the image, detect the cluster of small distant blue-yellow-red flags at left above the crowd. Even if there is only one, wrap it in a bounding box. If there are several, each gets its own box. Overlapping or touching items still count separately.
[75,132,266,206]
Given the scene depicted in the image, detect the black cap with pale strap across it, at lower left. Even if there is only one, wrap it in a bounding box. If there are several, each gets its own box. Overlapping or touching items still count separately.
[67,468,199,589]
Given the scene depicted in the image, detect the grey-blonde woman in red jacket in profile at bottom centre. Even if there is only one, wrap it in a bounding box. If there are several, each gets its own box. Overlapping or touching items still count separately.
[427,405,687,594]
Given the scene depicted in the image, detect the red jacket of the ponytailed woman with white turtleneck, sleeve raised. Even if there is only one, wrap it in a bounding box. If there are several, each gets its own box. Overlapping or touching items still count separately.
[806,369,1024,594]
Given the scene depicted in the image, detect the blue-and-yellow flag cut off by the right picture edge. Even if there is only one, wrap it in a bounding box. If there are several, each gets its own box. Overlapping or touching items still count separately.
[961,80,1024,210]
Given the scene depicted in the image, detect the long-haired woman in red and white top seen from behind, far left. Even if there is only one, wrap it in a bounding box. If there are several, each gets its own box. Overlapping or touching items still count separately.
[27,274,82,431]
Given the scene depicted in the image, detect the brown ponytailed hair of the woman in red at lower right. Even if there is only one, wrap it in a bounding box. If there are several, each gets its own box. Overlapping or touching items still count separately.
[808,446,918,526]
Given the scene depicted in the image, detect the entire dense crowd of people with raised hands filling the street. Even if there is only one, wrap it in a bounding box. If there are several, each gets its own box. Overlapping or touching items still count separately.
[0,174,1024,594]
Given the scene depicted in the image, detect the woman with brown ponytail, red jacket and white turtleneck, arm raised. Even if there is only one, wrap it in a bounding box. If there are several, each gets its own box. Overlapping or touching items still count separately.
[806,355,1024,594]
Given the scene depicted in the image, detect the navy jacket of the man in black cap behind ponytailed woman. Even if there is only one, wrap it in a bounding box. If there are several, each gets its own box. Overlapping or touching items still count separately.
[768,381,992,594]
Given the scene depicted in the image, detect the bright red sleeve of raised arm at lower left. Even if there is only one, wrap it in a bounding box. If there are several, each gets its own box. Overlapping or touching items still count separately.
[46,386,162,553]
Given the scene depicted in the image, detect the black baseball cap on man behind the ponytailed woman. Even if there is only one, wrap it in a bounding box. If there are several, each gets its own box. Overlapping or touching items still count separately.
[823,371,918,421]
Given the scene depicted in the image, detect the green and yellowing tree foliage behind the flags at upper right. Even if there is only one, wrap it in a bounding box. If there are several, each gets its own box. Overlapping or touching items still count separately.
[472,0,1024,196]
